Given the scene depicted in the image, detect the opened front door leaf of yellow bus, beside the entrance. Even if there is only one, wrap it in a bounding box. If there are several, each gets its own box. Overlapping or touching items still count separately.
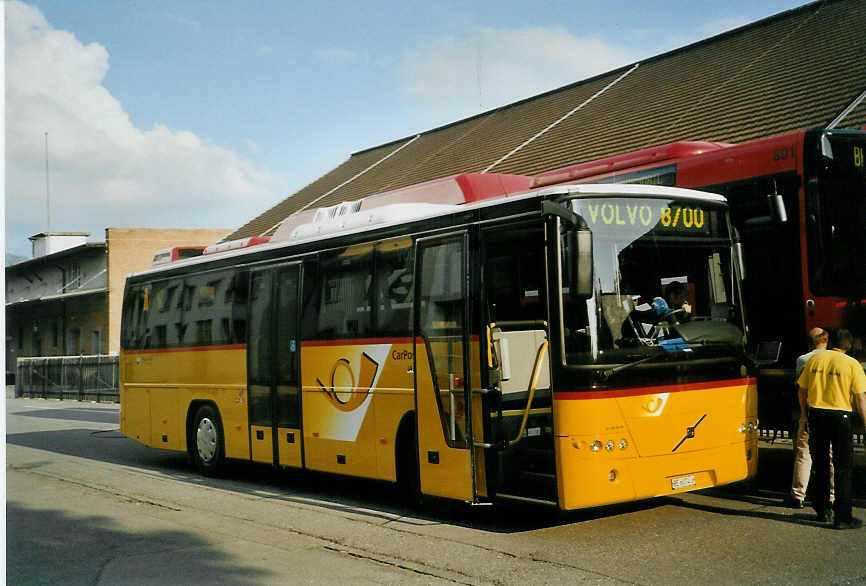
[414,232,476,501]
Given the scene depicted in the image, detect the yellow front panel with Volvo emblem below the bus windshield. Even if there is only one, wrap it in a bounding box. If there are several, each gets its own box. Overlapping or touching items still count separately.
[553,379,758,509]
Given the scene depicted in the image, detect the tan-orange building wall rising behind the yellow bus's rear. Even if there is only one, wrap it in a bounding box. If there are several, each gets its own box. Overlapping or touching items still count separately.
[105,228,229,353]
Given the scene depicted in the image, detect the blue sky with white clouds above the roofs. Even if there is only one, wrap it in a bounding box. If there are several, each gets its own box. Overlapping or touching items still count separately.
[3,0,804,257]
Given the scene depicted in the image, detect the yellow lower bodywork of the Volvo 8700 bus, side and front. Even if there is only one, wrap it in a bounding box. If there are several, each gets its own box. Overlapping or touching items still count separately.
[121,339,758,509]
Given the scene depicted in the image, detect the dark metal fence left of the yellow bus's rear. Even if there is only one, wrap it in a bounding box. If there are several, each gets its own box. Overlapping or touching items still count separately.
[15,356,120,402]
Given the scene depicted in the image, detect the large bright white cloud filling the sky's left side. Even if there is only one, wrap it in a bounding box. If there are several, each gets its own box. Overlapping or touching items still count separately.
[6,2,280,250]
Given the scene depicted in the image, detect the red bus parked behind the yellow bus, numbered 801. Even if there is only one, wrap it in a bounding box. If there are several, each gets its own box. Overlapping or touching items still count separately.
[533,129,866,423]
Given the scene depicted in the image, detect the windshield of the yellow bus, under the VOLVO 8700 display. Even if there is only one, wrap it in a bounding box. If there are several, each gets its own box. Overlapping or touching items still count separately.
[563,198,744,365]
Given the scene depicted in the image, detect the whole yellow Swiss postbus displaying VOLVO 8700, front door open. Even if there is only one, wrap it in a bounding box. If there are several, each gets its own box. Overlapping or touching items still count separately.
[120,176,758,509]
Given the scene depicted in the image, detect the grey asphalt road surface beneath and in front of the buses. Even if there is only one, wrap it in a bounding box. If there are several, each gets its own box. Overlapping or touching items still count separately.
[6,398,866,585]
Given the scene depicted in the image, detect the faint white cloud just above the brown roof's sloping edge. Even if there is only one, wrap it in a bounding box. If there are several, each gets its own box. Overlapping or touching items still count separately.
[397,26,637,118]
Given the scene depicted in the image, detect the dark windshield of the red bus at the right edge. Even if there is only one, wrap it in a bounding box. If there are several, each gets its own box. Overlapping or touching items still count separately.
[806,131,866,300]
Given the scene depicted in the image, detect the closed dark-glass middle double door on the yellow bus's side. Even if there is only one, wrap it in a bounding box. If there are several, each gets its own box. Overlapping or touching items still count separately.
[247,264,303,467]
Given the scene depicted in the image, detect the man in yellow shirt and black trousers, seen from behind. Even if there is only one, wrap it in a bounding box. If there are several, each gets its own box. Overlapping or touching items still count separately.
[797,329,866,529]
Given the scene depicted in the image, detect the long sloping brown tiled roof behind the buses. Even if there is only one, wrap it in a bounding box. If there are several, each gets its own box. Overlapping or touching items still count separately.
[226,0,866,240]
